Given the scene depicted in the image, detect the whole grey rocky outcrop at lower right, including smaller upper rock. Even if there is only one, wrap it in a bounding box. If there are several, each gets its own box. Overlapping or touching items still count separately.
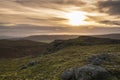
[61,54,113,80]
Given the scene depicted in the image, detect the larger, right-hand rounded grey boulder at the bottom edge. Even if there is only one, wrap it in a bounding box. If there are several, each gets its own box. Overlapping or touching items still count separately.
[75,64,110,80]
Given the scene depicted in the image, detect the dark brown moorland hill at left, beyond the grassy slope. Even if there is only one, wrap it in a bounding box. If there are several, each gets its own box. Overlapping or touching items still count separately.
[0,39,47,58]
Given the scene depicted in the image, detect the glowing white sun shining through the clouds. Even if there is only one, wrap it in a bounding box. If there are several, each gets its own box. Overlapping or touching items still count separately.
[66,11,86,26]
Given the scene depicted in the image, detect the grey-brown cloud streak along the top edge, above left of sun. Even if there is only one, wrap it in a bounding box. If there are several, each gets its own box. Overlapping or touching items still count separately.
[14,0,86,10]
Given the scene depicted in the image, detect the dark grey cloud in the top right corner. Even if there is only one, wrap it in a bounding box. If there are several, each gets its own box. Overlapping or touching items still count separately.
[98,0,120,16]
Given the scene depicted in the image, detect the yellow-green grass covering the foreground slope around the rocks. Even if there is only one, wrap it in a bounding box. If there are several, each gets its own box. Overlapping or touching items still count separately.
[0,44,120,80]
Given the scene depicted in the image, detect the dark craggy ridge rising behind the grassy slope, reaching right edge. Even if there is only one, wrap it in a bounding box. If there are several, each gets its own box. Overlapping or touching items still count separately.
[46,36,120,53]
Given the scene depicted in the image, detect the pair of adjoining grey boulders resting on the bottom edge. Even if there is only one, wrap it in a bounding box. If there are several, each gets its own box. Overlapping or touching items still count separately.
[61,64,110,80]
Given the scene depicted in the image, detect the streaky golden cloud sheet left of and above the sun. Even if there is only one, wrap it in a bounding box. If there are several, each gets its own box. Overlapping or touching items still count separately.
[0,0,109,26]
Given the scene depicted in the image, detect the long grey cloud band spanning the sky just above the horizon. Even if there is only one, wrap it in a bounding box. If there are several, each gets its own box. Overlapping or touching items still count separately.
[0,24,120,37]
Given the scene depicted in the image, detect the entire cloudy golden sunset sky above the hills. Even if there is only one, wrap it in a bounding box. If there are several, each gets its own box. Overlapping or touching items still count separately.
[0,0,120,37]
